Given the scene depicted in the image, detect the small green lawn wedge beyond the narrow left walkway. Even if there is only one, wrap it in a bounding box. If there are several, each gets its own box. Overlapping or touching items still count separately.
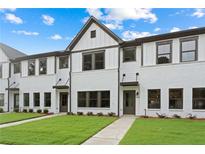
[0,113,44,124]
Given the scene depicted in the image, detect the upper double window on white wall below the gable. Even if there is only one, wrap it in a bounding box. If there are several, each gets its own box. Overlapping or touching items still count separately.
[83,51,105,71]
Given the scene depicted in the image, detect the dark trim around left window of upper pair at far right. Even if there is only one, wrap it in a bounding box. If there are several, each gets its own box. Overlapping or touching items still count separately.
[156,40,173,65]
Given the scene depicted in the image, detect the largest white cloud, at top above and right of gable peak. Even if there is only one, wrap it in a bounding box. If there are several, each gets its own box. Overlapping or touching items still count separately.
[83,8,157,29]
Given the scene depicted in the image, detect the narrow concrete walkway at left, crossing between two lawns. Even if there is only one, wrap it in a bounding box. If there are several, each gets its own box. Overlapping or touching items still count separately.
[0,113,66,128]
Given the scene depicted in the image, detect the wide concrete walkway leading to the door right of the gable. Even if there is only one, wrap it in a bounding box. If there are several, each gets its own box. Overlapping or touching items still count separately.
[82,116,136,145]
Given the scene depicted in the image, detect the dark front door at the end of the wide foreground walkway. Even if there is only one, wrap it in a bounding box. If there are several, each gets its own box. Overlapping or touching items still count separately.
[123,90,135,114]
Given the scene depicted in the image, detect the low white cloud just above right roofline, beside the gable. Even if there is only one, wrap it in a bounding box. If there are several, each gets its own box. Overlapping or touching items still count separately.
[122,30,154,40]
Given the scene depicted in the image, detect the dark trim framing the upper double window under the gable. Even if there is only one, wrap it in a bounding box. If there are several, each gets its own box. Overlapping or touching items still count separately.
[82,50,105,71]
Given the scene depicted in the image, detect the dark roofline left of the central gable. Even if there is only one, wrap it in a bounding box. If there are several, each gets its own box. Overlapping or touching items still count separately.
[11,50,69,62]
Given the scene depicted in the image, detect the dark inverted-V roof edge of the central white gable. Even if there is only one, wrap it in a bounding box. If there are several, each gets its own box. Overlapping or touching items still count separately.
[66,16,123,51]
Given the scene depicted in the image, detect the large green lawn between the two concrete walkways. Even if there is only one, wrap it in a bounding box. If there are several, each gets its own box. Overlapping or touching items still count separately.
[0,115,116,144]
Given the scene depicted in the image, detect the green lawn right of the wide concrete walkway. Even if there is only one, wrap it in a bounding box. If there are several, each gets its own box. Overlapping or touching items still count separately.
[120,119,205,145]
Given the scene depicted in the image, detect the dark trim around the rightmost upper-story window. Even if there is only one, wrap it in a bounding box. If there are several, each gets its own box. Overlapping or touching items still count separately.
[179,36,199,62]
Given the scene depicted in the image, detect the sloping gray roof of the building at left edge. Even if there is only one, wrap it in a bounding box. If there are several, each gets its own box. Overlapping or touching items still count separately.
[0,43,26,59]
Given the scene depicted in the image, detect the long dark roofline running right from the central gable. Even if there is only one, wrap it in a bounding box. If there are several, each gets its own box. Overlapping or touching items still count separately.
[121,27,205,47]
